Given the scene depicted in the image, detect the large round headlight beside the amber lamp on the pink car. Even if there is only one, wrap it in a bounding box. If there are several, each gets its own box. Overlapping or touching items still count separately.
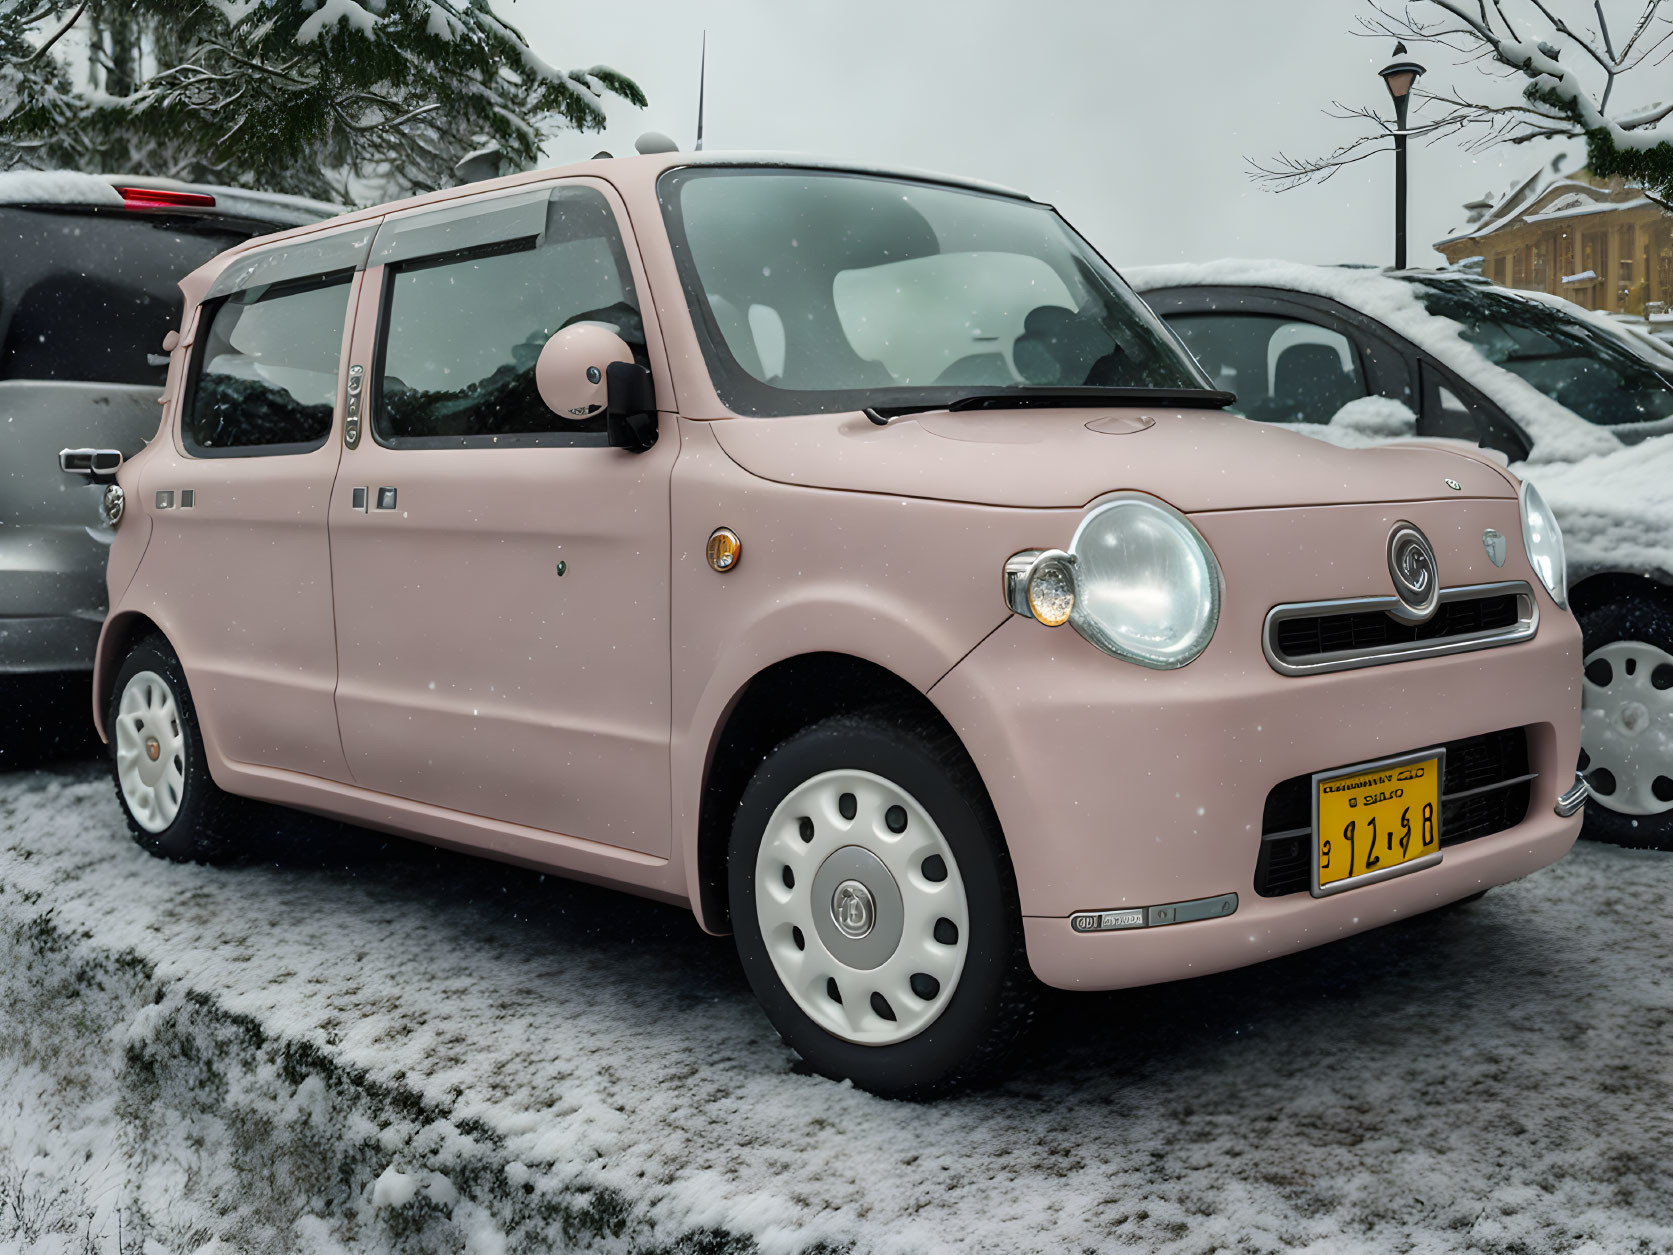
[1069,492,1220,669]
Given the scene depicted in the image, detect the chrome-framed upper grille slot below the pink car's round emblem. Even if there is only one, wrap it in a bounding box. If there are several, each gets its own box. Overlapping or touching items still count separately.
[1265,581,1539,676]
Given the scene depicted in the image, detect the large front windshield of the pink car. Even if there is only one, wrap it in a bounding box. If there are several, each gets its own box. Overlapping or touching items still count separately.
[659,167,1210,415]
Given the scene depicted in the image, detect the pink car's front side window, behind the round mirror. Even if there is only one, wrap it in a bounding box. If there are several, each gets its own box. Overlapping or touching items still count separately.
[373,187,646,447]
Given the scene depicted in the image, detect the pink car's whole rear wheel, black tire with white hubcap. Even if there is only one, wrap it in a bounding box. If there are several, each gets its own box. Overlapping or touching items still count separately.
[105,636,246,862]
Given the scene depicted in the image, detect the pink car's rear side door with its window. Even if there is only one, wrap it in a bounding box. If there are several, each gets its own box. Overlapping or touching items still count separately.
[130,223,376,780]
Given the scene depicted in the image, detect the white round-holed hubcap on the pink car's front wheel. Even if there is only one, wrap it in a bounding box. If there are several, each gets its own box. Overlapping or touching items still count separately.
[755,771,970,1046]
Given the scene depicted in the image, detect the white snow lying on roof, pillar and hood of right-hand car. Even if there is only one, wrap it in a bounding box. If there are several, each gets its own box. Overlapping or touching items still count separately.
[1121,259,1673,579]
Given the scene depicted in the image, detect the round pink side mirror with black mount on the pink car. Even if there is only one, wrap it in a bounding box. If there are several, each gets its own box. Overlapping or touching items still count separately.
[534,323,656,453]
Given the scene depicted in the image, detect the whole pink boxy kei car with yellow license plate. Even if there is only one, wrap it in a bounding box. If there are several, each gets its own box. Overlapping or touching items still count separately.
[64,154,1584,1094]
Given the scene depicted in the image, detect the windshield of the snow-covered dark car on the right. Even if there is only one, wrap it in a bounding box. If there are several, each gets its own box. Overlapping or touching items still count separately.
[1414,279,1673,437]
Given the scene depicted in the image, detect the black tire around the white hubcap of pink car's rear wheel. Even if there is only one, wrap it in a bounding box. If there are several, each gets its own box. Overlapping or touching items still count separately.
[105,634,251,863]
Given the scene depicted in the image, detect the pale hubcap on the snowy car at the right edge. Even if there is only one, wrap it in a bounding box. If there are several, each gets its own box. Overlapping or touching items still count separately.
[1579,641,1673,815]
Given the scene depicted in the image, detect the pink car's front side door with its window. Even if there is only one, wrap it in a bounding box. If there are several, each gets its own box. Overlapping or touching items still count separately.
[331,179,678,857]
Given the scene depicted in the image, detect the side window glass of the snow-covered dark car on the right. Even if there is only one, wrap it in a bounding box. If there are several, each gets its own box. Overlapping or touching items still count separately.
[1168,313,1370,423]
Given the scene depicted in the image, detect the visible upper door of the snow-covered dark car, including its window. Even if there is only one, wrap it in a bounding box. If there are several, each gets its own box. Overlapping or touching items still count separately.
[1144,288,1417,423]
